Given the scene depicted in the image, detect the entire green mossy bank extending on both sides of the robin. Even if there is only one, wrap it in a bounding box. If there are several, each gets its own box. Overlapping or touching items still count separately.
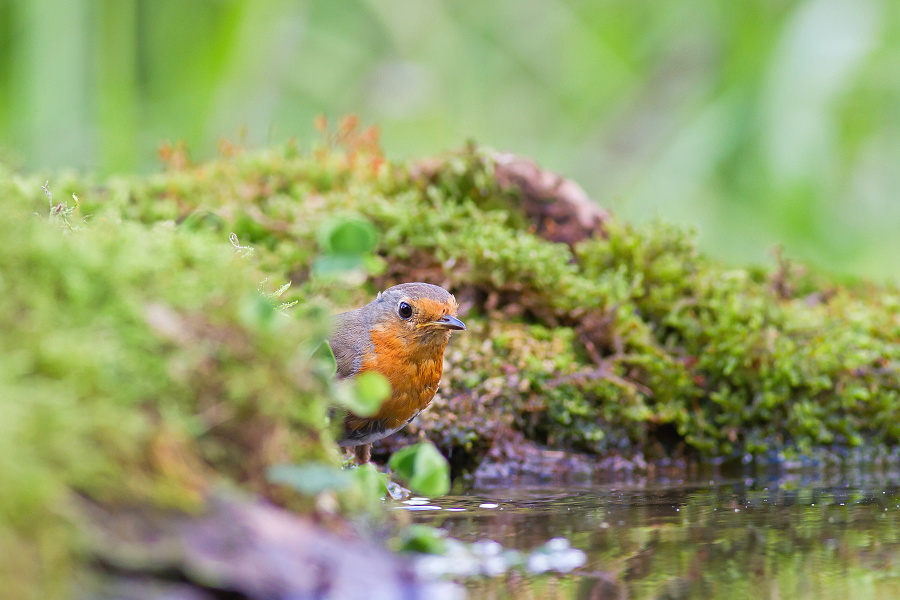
[0,122,900,596]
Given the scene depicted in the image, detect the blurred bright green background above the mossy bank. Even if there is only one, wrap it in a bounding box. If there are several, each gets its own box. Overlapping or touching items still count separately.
[0,0,900,280]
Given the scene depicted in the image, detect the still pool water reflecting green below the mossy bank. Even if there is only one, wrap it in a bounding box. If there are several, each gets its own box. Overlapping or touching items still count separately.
[398,476,900,600]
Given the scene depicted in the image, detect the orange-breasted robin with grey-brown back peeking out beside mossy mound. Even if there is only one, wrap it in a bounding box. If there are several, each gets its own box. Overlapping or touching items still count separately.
[329,283,466,464]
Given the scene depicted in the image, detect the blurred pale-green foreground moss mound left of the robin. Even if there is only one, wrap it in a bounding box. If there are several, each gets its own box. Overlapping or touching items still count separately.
[0,194,339,598]
